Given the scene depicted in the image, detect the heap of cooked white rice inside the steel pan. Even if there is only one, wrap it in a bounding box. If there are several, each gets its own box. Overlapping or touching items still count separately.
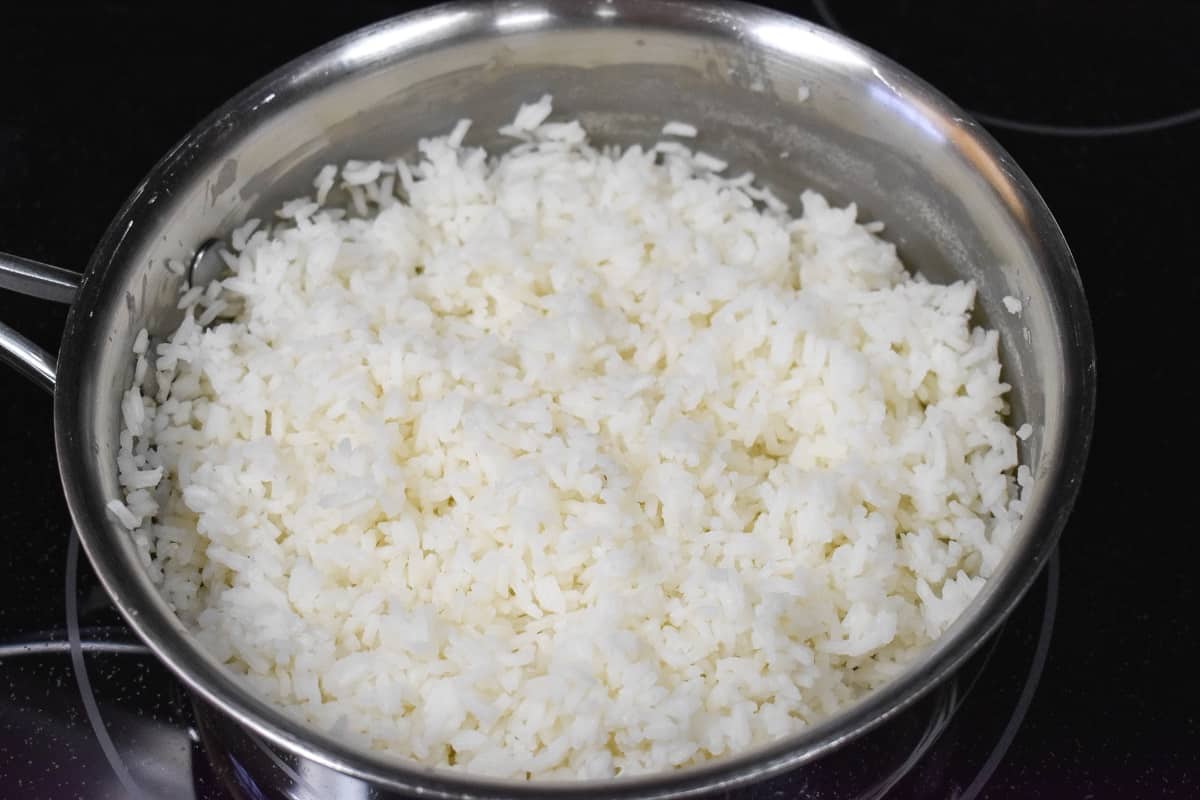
[109,97,1030,778]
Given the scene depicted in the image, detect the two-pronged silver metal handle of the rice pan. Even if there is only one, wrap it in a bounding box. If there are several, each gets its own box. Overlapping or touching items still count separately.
[0,253,83,395]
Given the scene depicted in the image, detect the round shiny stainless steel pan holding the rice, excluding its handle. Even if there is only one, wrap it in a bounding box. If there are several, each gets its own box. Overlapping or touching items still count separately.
[0,0,1096,798]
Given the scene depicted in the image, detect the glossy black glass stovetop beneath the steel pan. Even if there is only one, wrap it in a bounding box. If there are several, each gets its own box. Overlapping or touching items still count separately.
[0,0,1200,800]
